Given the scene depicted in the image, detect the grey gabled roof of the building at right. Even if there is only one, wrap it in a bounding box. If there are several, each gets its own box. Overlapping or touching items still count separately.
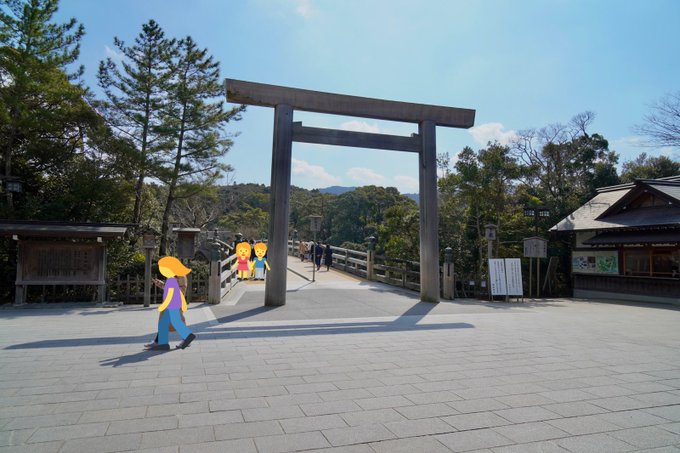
[550,176,680,232]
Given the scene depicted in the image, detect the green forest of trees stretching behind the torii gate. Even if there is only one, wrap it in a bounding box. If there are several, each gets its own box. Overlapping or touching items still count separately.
[0,0,680,301]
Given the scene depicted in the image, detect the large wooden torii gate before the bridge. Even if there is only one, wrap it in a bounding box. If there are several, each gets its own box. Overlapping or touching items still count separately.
[224,79,475,306]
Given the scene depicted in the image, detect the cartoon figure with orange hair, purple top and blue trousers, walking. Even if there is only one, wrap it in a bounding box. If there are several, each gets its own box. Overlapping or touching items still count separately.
[149,256,196,351]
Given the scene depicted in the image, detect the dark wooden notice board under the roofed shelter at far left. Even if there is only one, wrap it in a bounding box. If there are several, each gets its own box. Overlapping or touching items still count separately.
[16,241,105,285]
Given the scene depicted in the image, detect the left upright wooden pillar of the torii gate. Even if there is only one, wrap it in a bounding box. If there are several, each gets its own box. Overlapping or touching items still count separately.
[264,104,293,307]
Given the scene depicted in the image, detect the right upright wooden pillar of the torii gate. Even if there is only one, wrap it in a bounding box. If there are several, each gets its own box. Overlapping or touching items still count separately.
[418,121,439,302]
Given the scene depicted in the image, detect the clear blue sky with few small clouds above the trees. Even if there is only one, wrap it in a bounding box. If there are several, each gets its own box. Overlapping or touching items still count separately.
[57,0,680,192]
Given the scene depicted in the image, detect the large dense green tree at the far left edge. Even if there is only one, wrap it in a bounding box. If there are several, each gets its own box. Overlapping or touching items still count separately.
[0,0,89,212]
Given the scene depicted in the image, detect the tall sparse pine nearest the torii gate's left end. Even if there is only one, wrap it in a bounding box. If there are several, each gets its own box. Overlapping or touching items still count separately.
[159,36,245,255]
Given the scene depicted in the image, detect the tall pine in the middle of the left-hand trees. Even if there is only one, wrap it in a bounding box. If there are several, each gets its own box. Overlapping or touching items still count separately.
[97,20,176,228]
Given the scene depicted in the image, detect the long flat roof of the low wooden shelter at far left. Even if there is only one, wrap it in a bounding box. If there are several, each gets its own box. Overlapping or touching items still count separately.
[0,220,133,238]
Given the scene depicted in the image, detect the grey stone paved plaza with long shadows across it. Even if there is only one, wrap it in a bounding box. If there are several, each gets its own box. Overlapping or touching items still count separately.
[0,261,680,453]
